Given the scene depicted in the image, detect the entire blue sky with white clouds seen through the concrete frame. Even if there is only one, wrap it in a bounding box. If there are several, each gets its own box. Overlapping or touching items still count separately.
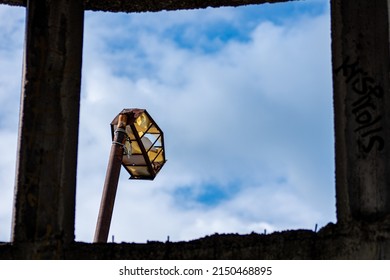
[0,0,335,242]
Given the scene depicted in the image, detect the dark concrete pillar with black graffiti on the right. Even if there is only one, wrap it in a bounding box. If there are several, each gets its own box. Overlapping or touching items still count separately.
[331,0,390,223]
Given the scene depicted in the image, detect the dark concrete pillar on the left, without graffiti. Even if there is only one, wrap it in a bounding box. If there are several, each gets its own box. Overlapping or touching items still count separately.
[12,0,84,243]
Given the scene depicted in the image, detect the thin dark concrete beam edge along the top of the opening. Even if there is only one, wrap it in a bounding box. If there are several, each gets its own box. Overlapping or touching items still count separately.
[0,0,298,13]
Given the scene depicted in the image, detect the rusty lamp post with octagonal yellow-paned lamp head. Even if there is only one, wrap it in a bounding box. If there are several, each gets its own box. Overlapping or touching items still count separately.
[94,109,166,243]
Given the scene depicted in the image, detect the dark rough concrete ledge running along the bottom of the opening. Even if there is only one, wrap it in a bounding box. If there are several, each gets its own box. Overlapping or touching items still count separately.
[0,221,390,260]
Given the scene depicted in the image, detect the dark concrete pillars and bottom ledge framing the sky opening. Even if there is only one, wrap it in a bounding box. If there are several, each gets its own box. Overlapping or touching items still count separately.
[0,0,390,259]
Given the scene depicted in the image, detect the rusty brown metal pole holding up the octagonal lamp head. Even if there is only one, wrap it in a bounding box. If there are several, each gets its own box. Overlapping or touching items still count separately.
[94,114,127,243]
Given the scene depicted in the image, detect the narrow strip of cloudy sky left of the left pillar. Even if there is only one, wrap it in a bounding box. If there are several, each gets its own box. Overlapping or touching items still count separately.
[0,6,24,241]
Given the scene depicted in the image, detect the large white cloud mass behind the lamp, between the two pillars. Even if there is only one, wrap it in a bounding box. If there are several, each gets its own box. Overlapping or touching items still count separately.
[77,3,334,242]
